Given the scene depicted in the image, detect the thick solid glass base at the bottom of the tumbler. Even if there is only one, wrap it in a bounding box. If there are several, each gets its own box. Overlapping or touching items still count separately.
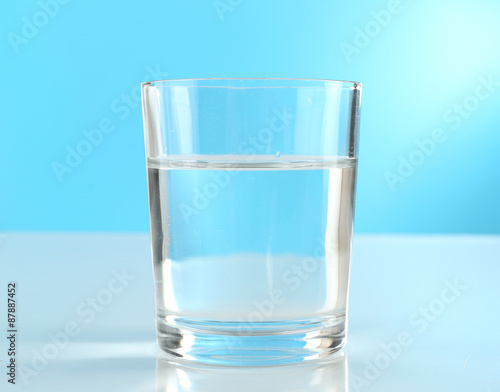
[157,315,346,366]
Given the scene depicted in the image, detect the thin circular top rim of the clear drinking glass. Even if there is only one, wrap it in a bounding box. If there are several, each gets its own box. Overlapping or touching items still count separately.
[141,77,362,89]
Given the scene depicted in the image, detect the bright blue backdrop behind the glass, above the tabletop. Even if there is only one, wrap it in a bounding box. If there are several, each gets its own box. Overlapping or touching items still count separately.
[0,0,500,233]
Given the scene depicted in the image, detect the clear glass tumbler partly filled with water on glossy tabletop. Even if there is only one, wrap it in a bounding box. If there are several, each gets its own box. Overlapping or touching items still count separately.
[142,79,361,366]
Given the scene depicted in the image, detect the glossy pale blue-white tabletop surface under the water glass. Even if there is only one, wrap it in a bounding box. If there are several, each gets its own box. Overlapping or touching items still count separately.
[0,233,500,392]
